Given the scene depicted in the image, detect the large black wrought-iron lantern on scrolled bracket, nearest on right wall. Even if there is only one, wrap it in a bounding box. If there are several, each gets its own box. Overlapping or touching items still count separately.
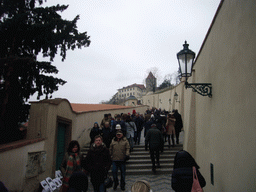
[177,41,212,97]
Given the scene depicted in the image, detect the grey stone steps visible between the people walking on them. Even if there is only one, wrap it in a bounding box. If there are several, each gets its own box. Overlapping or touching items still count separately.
[81,141,183,175]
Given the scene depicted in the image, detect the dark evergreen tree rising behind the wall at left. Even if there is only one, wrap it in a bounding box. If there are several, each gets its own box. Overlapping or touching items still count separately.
[0,0,90,143]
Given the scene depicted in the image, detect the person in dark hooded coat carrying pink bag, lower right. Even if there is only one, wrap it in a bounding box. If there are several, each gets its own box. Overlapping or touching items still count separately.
[172,150,206,192]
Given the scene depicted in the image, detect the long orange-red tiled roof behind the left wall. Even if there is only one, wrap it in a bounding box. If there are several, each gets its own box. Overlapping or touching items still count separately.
[70,103,131,112]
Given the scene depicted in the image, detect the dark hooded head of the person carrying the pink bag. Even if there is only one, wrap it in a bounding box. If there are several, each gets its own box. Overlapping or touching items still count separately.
[174,150,200,169]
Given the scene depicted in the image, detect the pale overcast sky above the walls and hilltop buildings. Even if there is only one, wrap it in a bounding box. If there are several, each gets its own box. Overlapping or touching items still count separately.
[30,0,220,103]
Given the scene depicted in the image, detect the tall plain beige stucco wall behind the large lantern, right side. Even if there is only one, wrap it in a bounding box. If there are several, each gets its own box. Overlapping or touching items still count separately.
[194,0,256,191]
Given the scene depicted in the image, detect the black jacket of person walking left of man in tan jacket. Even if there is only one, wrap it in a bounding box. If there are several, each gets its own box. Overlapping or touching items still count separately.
[82,144,112,185]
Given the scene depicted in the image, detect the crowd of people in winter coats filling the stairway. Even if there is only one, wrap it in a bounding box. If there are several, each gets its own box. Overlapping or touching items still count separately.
[58,109,205,192]
